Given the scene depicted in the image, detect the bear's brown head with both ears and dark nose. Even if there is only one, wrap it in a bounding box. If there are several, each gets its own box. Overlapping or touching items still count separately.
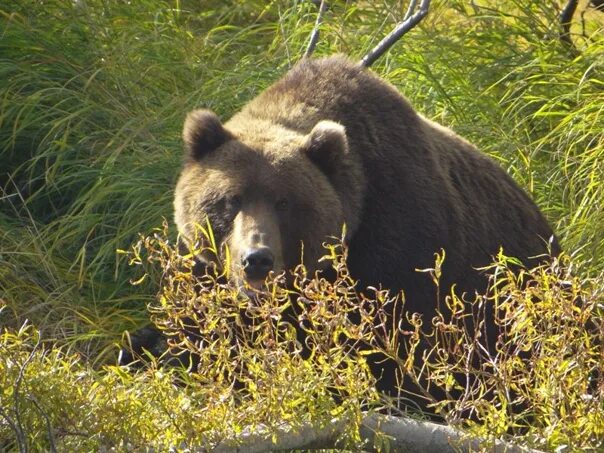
[174,110,359,288]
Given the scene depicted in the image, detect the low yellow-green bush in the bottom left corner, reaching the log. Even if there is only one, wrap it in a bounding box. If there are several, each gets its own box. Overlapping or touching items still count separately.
[0,326,358,451]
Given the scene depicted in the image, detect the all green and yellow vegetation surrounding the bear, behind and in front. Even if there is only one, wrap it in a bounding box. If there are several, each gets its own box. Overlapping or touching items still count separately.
[0,0,604,451]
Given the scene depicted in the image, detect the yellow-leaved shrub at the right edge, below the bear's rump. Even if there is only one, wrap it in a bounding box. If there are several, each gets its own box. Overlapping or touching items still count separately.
[417,254,604,450]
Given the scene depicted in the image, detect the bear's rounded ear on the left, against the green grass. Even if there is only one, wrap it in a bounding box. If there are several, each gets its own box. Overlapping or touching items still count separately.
[182,109,233,160]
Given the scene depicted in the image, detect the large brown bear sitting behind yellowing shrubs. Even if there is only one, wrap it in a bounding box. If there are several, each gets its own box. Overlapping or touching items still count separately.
[168,56,559,404]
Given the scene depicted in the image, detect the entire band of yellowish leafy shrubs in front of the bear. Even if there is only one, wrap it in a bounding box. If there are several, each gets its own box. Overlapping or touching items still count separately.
[0,226,604,450]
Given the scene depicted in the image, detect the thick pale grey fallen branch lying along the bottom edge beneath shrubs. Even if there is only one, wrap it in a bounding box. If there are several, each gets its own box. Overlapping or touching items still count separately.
[209,414,536,453]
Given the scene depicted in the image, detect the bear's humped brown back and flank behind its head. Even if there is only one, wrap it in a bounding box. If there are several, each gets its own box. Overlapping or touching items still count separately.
[234,56,559,305]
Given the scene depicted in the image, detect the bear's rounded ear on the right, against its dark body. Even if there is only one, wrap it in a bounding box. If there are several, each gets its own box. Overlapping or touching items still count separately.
[303,120,348,176]
